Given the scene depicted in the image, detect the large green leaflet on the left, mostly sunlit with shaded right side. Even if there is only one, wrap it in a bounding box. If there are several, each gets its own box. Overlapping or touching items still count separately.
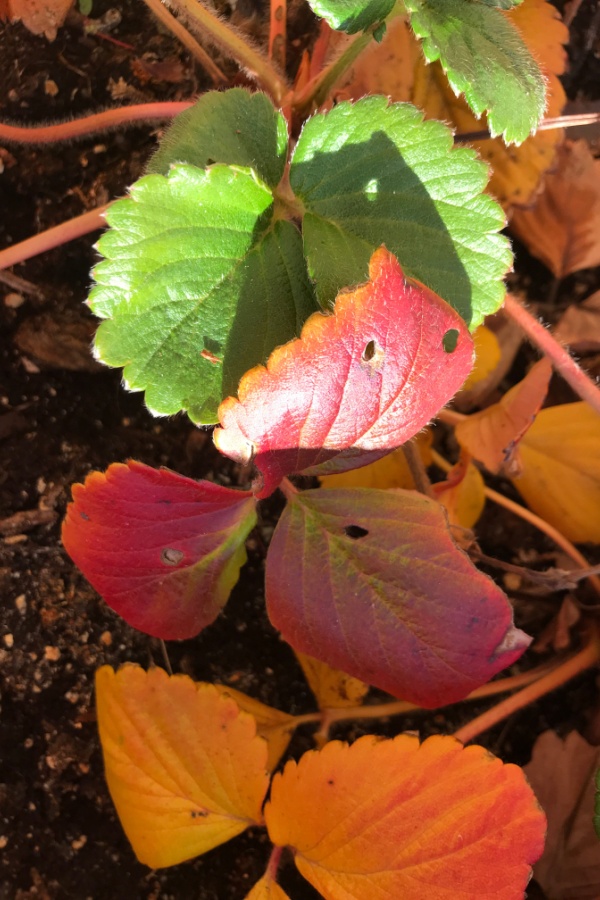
[90,165,315,424]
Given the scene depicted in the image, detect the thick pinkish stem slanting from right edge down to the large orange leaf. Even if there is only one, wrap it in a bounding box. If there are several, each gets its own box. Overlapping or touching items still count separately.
[454,634,600,744]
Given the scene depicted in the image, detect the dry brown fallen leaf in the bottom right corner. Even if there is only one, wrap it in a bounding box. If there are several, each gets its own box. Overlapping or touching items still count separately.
[524,731,600,900]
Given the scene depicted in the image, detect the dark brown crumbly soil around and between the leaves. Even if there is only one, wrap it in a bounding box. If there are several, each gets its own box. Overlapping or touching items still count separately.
[0,0,600,900]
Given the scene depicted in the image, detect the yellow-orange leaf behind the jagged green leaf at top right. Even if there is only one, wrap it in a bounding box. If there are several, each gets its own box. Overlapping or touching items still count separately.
[340,0,569,208]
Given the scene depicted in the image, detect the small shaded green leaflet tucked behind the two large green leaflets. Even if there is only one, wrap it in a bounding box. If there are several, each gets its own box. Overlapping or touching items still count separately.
[147,88,288,187]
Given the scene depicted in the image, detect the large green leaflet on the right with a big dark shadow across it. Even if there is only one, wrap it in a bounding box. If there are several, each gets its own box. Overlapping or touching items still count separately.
[290,96,512,328]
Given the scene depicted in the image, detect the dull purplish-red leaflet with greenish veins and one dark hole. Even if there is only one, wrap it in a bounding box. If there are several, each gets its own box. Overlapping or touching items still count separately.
[266,488,529,707]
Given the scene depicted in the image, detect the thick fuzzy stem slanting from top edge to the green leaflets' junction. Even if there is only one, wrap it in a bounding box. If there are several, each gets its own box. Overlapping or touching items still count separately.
[163,0,289,104]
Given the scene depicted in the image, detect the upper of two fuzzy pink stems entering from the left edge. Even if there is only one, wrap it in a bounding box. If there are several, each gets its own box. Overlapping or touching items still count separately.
[0,101,192,144]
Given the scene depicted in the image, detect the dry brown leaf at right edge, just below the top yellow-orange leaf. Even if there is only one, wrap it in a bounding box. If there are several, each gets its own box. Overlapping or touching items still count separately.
[511,141,600,278]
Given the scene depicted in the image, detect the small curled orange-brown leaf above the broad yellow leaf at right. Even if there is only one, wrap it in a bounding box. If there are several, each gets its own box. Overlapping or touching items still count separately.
[456,357,552,476]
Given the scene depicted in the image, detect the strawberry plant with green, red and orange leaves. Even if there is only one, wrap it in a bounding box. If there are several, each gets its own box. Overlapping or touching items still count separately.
[5,0,598,900]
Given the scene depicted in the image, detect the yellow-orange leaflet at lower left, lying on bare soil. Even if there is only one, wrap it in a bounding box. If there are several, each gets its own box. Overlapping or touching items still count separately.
[96,665,269,868]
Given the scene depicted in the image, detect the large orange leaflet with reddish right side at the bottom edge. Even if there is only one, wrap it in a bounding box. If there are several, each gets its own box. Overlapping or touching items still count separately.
[265,735,545,900]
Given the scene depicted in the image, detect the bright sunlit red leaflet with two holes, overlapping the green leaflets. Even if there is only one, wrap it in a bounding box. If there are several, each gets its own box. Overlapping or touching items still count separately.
[214,248,473,497]
